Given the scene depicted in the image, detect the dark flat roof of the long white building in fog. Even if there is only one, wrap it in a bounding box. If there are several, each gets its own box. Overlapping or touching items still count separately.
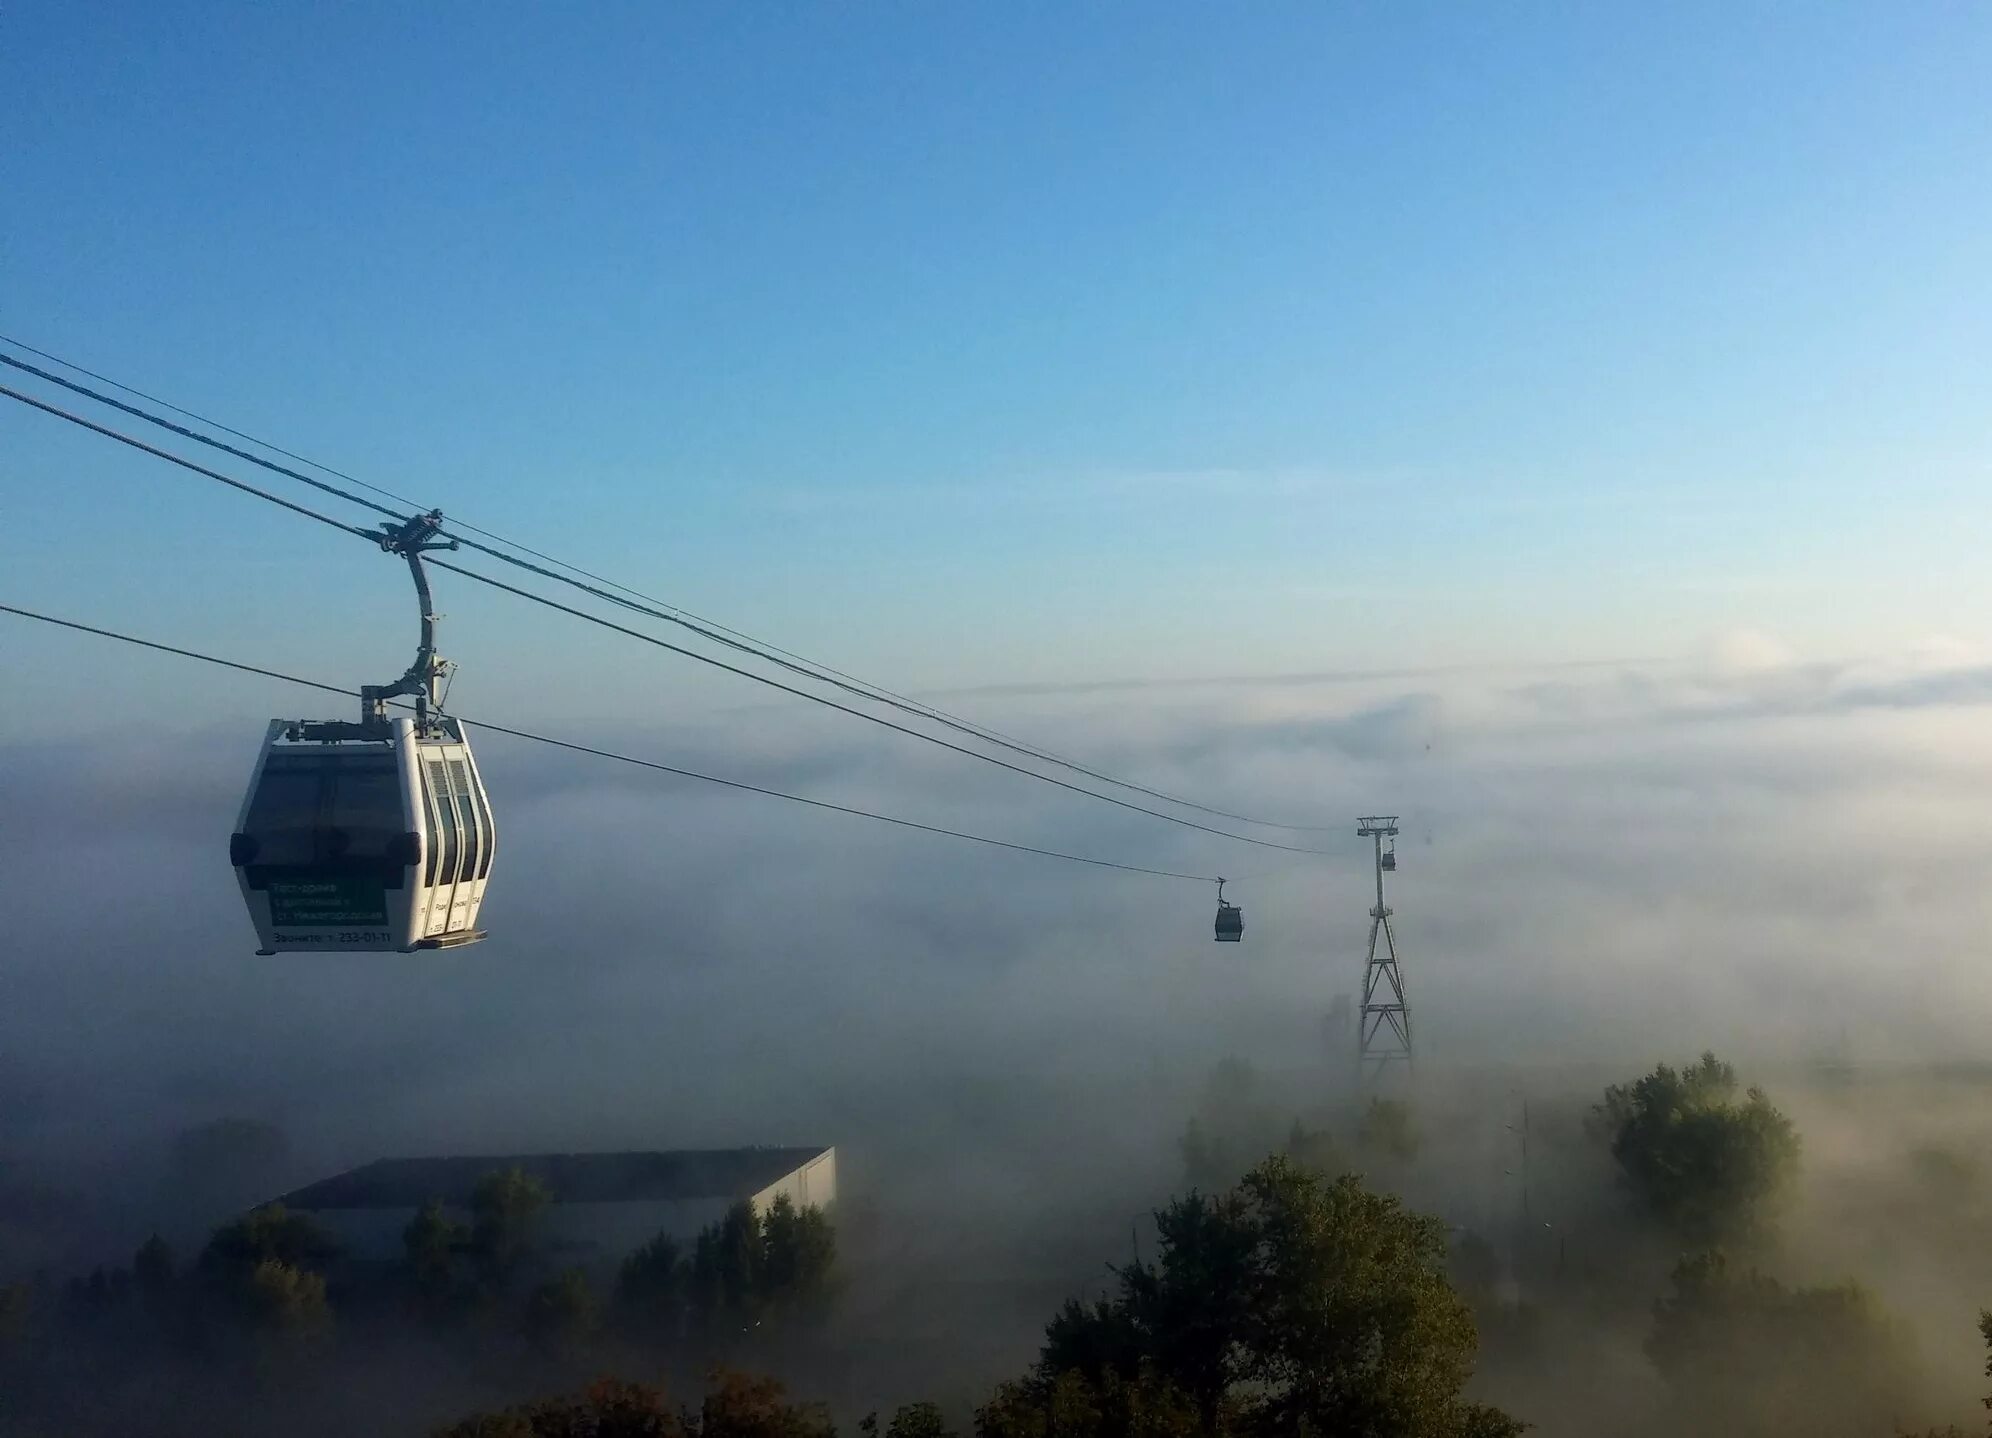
[279,1145,829,1209]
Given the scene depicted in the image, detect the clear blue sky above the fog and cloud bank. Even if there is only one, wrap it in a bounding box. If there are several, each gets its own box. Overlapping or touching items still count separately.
[0,0,1992,723]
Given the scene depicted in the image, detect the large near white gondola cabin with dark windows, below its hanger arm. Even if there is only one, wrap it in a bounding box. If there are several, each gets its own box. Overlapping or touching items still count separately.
[229,717,496,954]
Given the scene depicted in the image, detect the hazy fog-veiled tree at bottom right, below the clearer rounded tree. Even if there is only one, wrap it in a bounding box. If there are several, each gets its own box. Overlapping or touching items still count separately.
[1645,1251,1918,1438]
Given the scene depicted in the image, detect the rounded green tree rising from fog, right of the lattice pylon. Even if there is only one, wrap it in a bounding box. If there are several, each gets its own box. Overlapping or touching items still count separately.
[1592,1054,1799,1245]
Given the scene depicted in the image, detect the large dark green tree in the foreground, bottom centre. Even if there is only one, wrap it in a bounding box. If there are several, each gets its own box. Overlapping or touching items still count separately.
[1027,1157,1520,1438]
